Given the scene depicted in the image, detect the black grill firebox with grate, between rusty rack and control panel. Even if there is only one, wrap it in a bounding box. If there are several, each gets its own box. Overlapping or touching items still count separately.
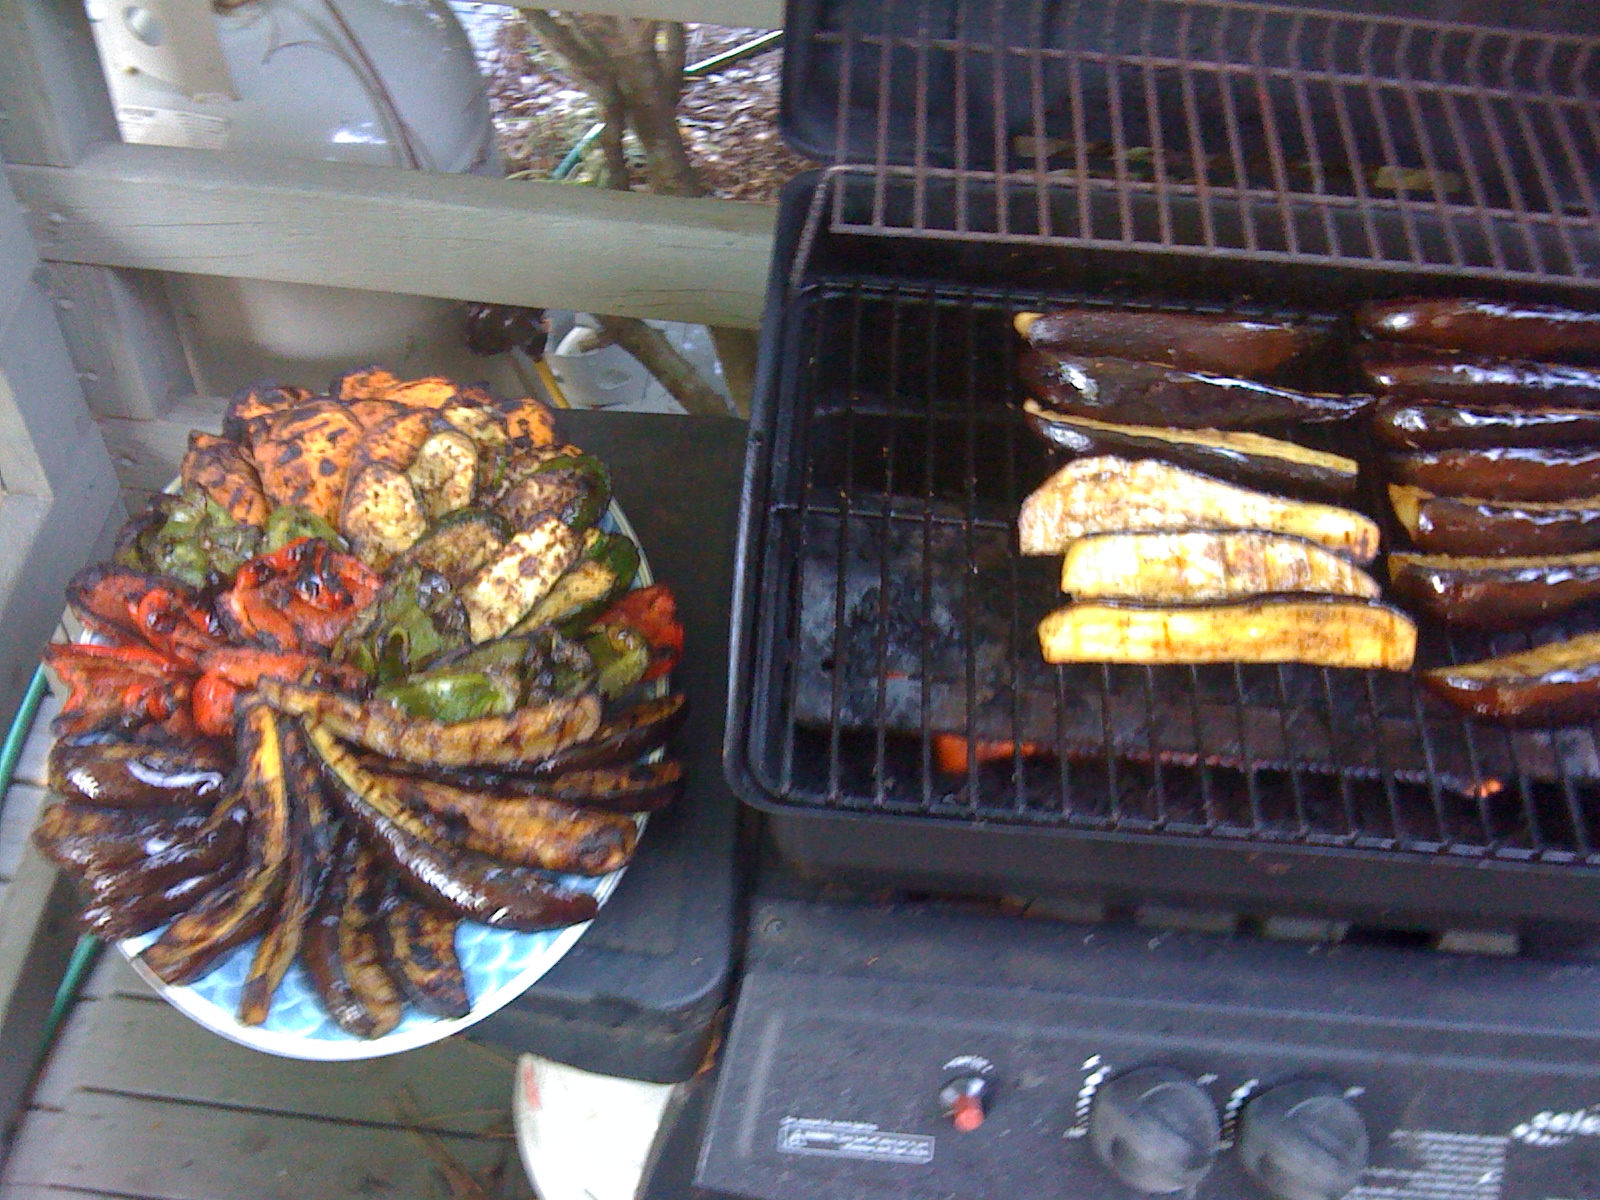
[725,176,1600,926]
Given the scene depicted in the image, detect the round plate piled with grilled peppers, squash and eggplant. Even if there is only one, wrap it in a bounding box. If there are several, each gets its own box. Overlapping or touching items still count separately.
[34,368,683,1059]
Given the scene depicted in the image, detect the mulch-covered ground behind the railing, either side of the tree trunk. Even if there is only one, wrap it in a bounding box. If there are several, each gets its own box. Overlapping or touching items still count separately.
[480,18,811,202]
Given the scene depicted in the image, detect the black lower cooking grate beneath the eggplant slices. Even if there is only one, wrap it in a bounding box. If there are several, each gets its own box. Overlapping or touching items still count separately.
[749,278,1600,867]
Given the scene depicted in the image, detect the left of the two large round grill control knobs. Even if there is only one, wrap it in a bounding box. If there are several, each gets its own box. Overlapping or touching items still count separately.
[1090,1067,1222,1195]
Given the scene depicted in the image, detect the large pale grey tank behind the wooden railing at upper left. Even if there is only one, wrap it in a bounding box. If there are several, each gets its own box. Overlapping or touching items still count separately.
[90,0,522,395]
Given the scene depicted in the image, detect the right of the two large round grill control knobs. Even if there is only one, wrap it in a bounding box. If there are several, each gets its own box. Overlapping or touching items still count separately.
[1238,1080,1368,1200]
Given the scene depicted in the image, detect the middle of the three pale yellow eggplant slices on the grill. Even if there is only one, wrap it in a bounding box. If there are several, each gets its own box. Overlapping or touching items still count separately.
[1061,531,1379,603]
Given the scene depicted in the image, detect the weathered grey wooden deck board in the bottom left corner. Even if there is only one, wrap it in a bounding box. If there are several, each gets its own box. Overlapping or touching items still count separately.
[0,1091,533,1200]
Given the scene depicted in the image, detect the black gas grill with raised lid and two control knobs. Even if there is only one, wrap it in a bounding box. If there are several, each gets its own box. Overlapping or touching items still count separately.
[698,0,1600,1200]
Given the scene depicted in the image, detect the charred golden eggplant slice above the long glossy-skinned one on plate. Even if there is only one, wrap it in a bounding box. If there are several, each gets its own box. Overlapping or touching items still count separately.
[357,755,638,875]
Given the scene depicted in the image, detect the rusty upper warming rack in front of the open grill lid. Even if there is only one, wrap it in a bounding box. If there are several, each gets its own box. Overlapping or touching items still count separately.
[784,0,1600,288]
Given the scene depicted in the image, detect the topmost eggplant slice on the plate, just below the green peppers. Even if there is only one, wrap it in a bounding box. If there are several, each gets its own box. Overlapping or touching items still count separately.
[258,678,600,766]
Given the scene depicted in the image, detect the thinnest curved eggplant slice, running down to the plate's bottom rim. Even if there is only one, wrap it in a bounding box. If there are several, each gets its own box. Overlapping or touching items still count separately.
[238,720,333,1026]
